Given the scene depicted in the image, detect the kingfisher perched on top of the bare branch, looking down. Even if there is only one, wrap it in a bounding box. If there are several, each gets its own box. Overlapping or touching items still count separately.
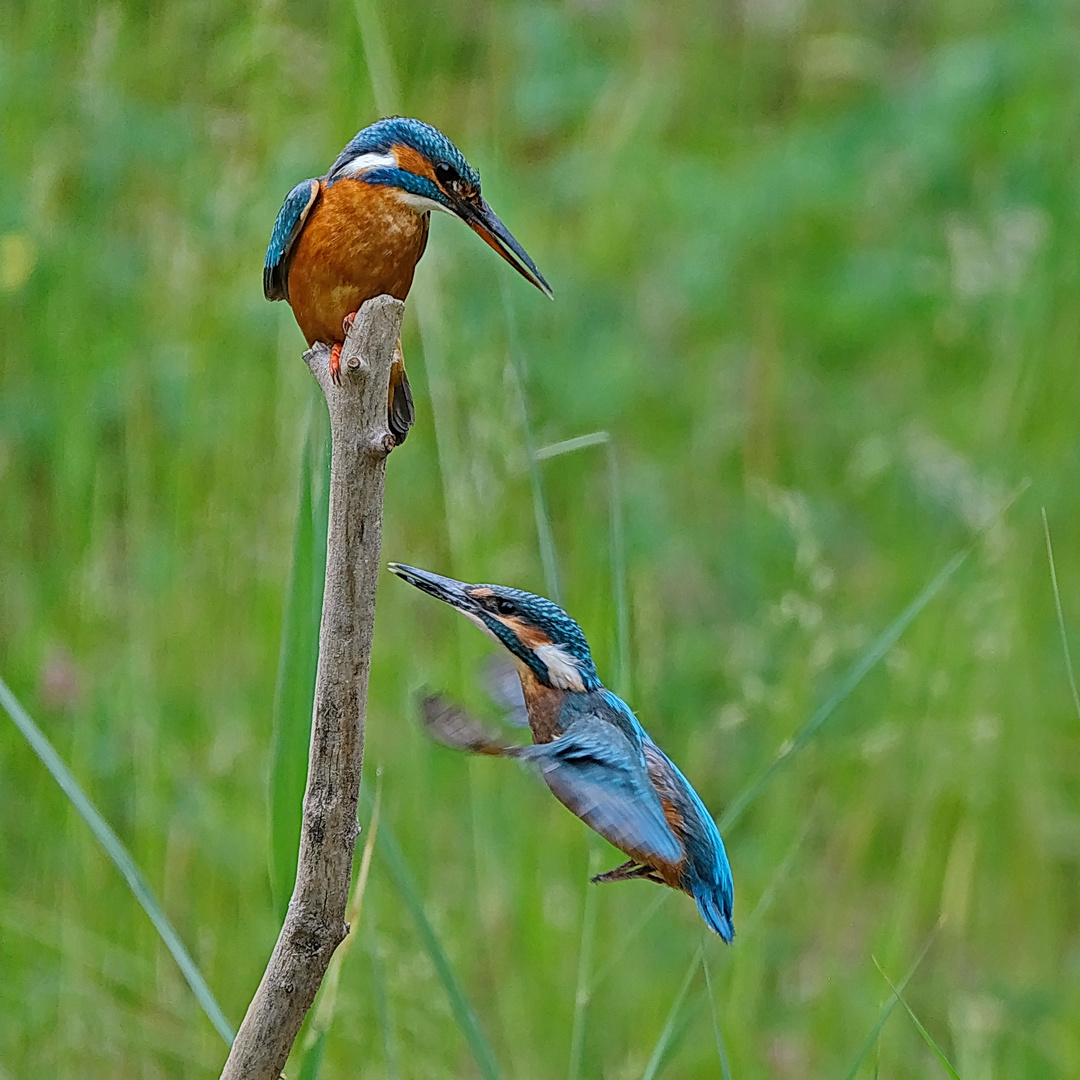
[262,117,552,444]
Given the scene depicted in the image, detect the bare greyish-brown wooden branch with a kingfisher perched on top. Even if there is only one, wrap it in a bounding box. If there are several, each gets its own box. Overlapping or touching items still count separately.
[221,296,405,1080]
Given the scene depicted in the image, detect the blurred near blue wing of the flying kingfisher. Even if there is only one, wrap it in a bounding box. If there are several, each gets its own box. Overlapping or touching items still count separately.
[514,715,684,864]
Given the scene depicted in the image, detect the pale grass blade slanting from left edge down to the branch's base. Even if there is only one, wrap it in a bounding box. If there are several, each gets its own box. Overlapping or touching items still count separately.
[0,678,235,1045]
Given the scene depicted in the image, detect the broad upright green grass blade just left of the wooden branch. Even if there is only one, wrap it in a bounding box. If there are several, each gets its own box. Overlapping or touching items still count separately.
[269,401,329,919]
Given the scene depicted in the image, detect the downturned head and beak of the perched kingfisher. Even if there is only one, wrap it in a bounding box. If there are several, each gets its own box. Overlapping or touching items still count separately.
[326,117,552,297]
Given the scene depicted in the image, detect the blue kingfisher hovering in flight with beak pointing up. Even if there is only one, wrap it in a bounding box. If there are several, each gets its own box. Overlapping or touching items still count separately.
[389,563,734,943]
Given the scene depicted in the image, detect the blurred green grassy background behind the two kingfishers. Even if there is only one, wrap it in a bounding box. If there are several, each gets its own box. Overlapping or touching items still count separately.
[0,0,1080,1080]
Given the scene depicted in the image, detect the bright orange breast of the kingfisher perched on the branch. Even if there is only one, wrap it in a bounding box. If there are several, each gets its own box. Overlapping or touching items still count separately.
[288,179,428,345]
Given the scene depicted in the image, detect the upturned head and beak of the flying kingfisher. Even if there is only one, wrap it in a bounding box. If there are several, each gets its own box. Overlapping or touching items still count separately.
[390,563,600,691]
